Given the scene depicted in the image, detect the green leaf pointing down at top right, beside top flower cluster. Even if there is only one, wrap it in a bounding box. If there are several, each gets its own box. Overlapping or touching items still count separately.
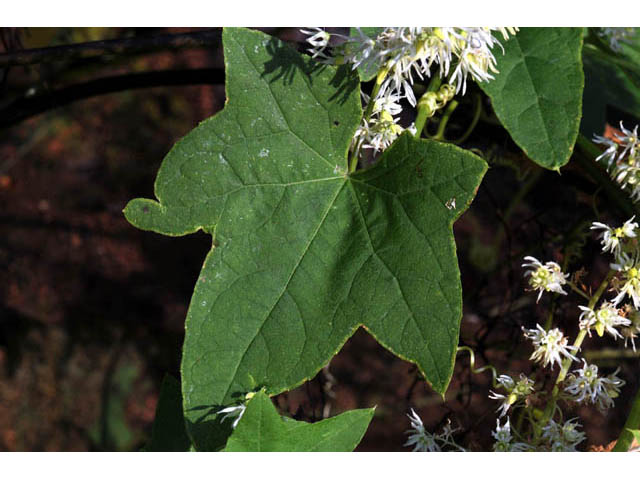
[478,28,584,170]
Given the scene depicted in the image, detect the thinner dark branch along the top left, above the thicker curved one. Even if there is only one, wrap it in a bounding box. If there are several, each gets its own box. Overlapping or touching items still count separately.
[0,29,222,68]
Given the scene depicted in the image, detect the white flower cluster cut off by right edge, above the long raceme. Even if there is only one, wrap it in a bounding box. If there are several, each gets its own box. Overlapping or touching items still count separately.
[593,122,640,201]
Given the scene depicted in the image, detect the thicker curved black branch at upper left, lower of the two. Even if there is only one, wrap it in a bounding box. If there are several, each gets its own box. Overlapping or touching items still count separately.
[0,68,224,128]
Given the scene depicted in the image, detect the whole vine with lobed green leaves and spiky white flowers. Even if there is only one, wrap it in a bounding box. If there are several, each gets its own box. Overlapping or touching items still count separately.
[124,27,640,451]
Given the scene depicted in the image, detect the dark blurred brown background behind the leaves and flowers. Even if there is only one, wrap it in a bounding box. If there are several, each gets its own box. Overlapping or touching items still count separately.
[0,28,639,451]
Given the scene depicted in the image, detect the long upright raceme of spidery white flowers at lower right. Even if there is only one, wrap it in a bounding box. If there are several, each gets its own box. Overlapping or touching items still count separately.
[482,216,640,452]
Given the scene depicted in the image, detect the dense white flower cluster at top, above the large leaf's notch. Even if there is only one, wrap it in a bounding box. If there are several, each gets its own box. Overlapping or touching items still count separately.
[301,27,518,158]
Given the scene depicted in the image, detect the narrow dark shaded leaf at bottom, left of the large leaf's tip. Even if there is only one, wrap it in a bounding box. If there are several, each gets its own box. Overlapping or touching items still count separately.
[147,375,191,452]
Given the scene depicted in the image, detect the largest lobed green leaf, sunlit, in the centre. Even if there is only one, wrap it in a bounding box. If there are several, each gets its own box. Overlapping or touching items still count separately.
[125,29,486,450]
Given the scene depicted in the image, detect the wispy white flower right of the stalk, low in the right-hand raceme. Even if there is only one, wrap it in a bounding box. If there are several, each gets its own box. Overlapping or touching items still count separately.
[564,359,625,410]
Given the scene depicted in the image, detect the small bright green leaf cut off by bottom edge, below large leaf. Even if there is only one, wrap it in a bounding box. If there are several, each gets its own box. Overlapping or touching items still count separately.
[225,392,374,452]
